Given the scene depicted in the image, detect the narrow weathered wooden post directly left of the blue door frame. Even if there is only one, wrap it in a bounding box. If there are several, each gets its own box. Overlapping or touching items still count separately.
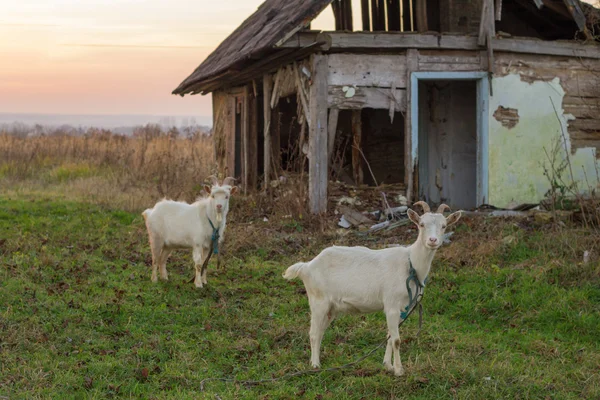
[404,49,419,202]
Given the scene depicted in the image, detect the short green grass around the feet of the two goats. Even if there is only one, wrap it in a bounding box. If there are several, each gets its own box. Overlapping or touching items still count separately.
[0,196,600,399]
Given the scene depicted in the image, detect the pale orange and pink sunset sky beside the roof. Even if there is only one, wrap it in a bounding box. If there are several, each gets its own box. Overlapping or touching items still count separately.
[0,0,596,121]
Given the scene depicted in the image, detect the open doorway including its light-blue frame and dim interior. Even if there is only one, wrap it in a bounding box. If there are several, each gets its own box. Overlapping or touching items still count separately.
[411,72,488,210]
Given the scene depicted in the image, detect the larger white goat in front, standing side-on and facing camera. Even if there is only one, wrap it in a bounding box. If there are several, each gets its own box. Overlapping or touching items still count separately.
[283,201,461,376]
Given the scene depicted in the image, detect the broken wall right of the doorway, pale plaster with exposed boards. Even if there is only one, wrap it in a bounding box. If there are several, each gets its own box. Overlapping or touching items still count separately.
[488,68,600,207]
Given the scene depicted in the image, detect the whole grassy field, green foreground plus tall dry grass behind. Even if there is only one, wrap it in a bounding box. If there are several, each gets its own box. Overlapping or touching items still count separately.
[0,136,600,400]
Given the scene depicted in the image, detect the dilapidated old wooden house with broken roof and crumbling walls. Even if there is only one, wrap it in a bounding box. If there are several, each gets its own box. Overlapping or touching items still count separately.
[173,0,600,213]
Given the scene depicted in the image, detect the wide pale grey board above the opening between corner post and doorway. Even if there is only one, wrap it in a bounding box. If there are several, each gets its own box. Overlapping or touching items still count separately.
[328,54,406,88]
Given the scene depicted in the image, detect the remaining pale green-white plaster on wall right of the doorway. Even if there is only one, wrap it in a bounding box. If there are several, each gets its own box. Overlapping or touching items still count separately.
[489,74,597,207]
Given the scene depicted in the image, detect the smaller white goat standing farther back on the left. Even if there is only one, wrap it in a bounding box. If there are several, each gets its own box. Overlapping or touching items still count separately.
[142,176,236,288]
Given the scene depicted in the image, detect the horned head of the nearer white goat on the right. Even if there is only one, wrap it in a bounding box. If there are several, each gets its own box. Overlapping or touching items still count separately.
[408,202,462,250]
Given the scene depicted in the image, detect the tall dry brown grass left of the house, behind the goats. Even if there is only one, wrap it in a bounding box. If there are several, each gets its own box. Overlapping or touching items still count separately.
[0,132,216,211]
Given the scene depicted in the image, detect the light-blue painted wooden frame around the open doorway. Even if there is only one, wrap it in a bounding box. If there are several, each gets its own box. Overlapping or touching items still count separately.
[410,72,490,206]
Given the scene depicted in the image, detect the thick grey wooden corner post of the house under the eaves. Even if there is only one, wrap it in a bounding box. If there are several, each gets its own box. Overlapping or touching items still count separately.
[308,54,328,214]
